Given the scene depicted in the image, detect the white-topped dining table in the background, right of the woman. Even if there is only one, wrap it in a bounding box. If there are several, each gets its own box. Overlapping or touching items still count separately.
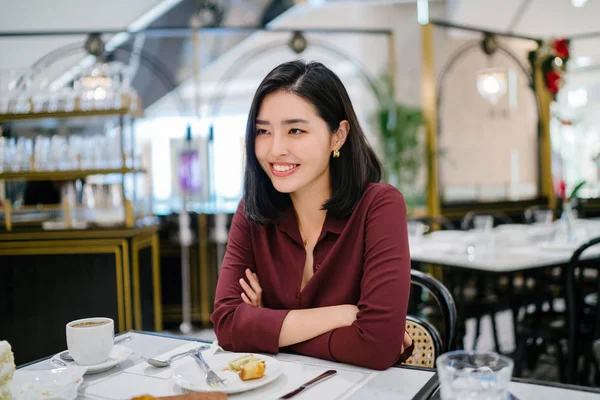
[409,219,600,275]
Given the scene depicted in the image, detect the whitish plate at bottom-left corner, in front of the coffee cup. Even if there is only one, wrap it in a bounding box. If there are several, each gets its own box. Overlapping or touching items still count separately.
[11,366,86,400]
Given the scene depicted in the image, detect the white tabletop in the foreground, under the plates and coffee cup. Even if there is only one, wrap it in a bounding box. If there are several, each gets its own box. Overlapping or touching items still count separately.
[16,331,600,400]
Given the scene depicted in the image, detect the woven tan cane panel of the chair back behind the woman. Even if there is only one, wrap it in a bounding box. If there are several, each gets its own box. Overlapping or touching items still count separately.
[402,315,442,368]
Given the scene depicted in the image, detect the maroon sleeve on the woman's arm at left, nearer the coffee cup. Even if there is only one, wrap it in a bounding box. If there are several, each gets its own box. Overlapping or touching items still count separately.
[211,204,288,353]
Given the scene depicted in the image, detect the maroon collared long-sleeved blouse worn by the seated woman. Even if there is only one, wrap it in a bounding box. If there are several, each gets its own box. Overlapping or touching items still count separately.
[211,183,410,369]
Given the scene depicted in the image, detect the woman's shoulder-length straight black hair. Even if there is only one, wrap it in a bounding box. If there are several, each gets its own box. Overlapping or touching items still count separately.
[244,60,381,224]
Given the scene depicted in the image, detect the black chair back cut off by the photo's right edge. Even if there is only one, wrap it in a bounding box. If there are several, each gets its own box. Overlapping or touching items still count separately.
[565,237,600,382]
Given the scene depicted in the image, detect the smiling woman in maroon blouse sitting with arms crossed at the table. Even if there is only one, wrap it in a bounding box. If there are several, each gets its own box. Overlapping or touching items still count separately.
[212,61,412,369]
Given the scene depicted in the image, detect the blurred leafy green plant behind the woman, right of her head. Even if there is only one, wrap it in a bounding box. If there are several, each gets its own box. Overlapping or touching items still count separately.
[371,75,424,207]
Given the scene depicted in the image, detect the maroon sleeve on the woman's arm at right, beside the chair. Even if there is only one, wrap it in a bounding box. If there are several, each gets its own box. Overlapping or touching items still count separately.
[291,187,410,370]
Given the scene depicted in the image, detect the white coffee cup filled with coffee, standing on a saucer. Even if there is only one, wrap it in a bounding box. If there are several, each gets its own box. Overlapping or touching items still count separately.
[67,317,115,365]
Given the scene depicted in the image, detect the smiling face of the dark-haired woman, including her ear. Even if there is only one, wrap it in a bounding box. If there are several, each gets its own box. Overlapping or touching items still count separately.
[254,91,349,194]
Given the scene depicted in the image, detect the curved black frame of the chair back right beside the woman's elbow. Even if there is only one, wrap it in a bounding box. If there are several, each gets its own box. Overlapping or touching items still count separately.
[407,270,457,356]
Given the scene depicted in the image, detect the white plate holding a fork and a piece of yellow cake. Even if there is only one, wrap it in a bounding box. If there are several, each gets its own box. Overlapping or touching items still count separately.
[171,353,283,394]
